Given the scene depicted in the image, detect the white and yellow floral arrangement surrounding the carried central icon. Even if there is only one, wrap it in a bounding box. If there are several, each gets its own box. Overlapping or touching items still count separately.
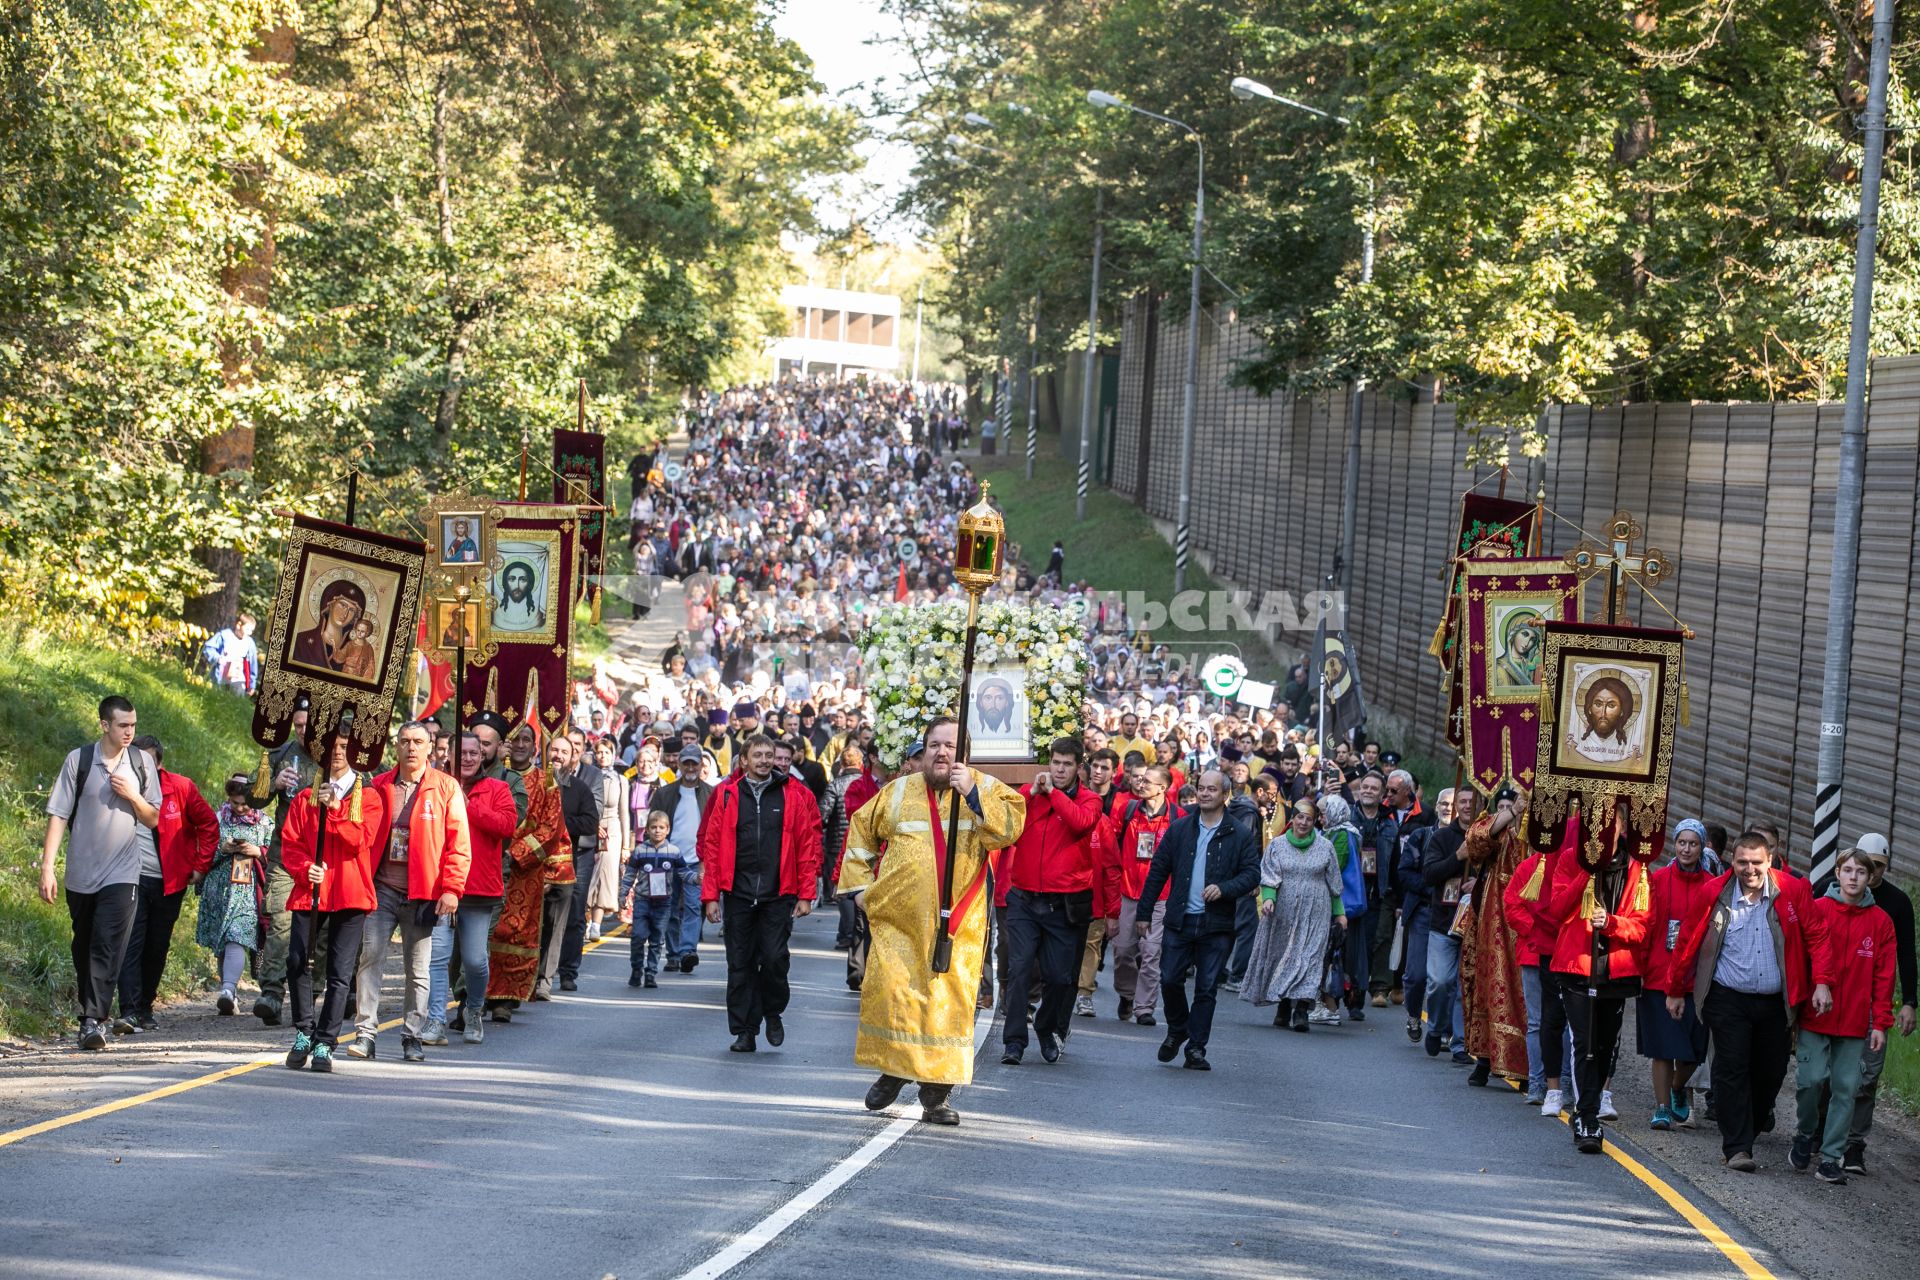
[860,601,1089,768]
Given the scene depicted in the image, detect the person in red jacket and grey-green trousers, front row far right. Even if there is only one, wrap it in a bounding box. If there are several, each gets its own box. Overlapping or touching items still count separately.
[1788,848,1895,1184]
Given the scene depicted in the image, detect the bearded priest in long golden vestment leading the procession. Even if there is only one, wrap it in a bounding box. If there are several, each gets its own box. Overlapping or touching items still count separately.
[839,716,1027,1125]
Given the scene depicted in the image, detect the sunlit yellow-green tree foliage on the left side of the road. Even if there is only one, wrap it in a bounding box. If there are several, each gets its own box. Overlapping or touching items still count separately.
[0,0,858,624]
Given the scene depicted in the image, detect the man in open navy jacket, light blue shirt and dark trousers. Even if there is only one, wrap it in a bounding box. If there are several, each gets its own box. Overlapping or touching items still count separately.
[1135,770,1260,1071]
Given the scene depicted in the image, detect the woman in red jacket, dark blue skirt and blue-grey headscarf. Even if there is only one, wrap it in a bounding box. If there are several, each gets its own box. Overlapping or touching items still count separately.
[1634,818,1715,1128]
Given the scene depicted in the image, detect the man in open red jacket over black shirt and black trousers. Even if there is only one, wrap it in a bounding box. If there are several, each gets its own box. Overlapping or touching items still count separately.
[695,733,820,1054]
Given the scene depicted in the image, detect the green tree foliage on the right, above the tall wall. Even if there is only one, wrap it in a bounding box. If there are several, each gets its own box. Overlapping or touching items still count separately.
[895,0,1920,458]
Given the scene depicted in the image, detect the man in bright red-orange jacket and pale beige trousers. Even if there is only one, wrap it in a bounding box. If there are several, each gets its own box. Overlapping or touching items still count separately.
[348,722,468,1063]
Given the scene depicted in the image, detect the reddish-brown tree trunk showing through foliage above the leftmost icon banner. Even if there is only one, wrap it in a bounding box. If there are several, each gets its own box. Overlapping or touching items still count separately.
[180,15,294,631]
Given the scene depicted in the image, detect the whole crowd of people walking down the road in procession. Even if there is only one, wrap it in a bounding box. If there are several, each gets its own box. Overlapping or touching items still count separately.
[42,384,1916,1182]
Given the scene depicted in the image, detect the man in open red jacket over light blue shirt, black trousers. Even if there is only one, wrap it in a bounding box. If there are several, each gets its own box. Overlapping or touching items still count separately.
[1667,831,1834,1173]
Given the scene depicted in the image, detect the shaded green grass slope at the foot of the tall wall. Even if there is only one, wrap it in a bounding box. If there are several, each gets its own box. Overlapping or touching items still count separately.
[968,454,1283,681]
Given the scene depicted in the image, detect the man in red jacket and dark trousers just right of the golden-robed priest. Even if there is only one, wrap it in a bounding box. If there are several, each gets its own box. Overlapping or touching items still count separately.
[995,737,1100,1067]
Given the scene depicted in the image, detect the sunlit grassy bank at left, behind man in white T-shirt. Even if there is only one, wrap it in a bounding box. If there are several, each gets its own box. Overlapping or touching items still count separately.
[0,628,259,1038]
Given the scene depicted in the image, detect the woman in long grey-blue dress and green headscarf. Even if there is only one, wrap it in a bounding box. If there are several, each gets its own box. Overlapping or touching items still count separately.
[1240,796,1346,1031]
